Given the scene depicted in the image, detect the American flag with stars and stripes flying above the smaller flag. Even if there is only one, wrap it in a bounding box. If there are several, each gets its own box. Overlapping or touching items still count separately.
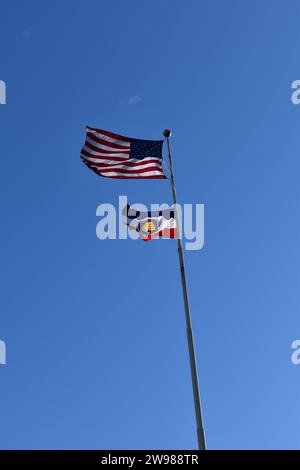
[80,127,165,179]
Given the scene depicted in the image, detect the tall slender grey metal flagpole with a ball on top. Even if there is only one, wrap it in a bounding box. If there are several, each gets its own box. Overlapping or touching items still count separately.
[164,129,206,450]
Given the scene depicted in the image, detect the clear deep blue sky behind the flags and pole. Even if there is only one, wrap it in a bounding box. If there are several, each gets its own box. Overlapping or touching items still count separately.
[0,0,300,449]
